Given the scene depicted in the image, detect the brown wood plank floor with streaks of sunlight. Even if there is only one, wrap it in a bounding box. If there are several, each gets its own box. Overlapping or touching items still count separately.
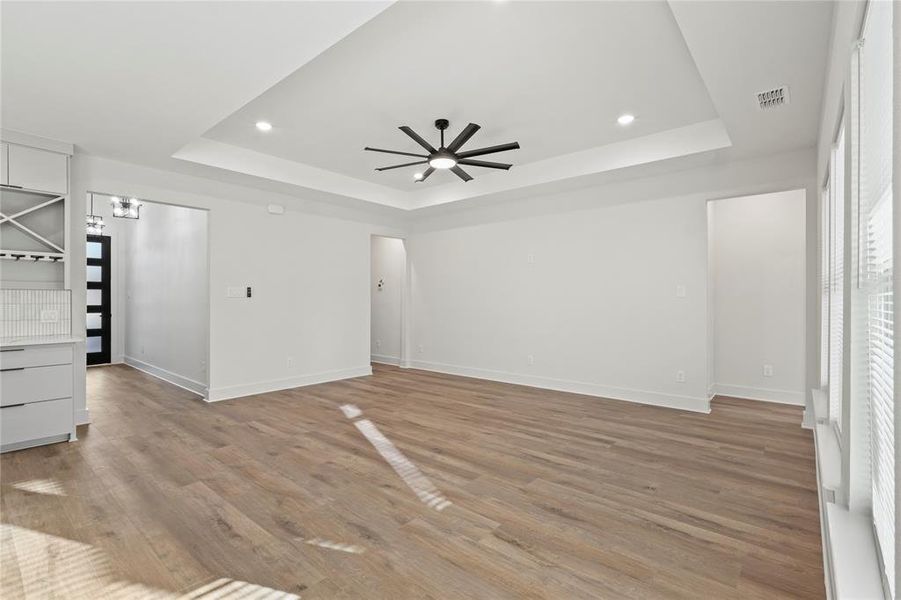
[0,366,825,600]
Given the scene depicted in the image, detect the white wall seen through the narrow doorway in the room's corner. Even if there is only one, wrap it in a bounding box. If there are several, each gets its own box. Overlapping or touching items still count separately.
[369,236,407,365]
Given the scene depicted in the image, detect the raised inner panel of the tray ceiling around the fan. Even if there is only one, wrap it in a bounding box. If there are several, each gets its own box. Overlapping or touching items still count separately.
[205,1,717,190]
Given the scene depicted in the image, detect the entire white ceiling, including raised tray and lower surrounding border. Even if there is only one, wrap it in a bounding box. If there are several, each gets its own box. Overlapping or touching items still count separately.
[0,0,832,209]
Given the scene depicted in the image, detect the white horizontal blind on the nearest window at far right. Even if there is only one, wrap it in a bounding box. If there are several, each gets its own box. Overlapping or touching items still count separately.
[859,2,895,597]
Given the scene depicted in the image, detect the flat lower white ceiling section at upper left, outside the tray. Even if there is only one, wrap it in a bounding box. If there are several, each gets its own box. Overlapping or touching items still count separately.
[0,0,390,166]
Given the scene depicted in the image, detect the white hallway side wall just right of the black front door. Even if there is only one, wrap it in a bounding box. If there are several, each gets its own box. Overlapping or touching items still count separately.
[122,202,209,395]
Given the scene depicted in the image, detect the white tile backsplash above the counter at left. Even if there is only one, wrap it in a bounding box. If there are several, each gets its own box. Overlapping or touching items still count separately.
[0,289,72,338]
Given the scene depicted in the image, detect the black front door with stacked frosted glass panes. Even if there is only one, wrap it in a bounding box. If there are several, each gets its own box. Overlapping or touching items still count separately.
[85,235,112,365]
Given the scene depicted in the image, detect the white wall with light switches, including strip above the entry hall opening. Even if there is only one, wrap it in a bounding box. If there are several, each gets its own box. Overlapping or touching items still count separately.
[70,154,406,422]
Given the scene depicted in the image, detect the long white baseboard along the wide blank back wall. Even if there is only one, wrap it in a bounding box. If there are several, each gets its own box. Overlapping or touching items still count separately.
[410,360,710,413]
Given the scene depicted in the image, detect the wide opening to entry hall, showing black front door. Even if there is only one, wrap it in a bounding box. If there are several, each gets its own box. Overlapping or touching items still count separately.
[85,192,209,402]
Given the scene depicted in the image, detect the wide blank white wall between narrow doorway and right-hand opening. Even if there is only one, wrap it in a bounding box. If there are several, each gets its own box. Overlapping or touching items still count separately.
[408,195,708,411]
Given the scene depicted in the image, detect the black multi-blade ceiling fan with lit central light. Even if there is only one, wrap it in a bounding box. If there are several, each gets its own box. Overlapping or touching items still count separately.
[364,119,519,181]
